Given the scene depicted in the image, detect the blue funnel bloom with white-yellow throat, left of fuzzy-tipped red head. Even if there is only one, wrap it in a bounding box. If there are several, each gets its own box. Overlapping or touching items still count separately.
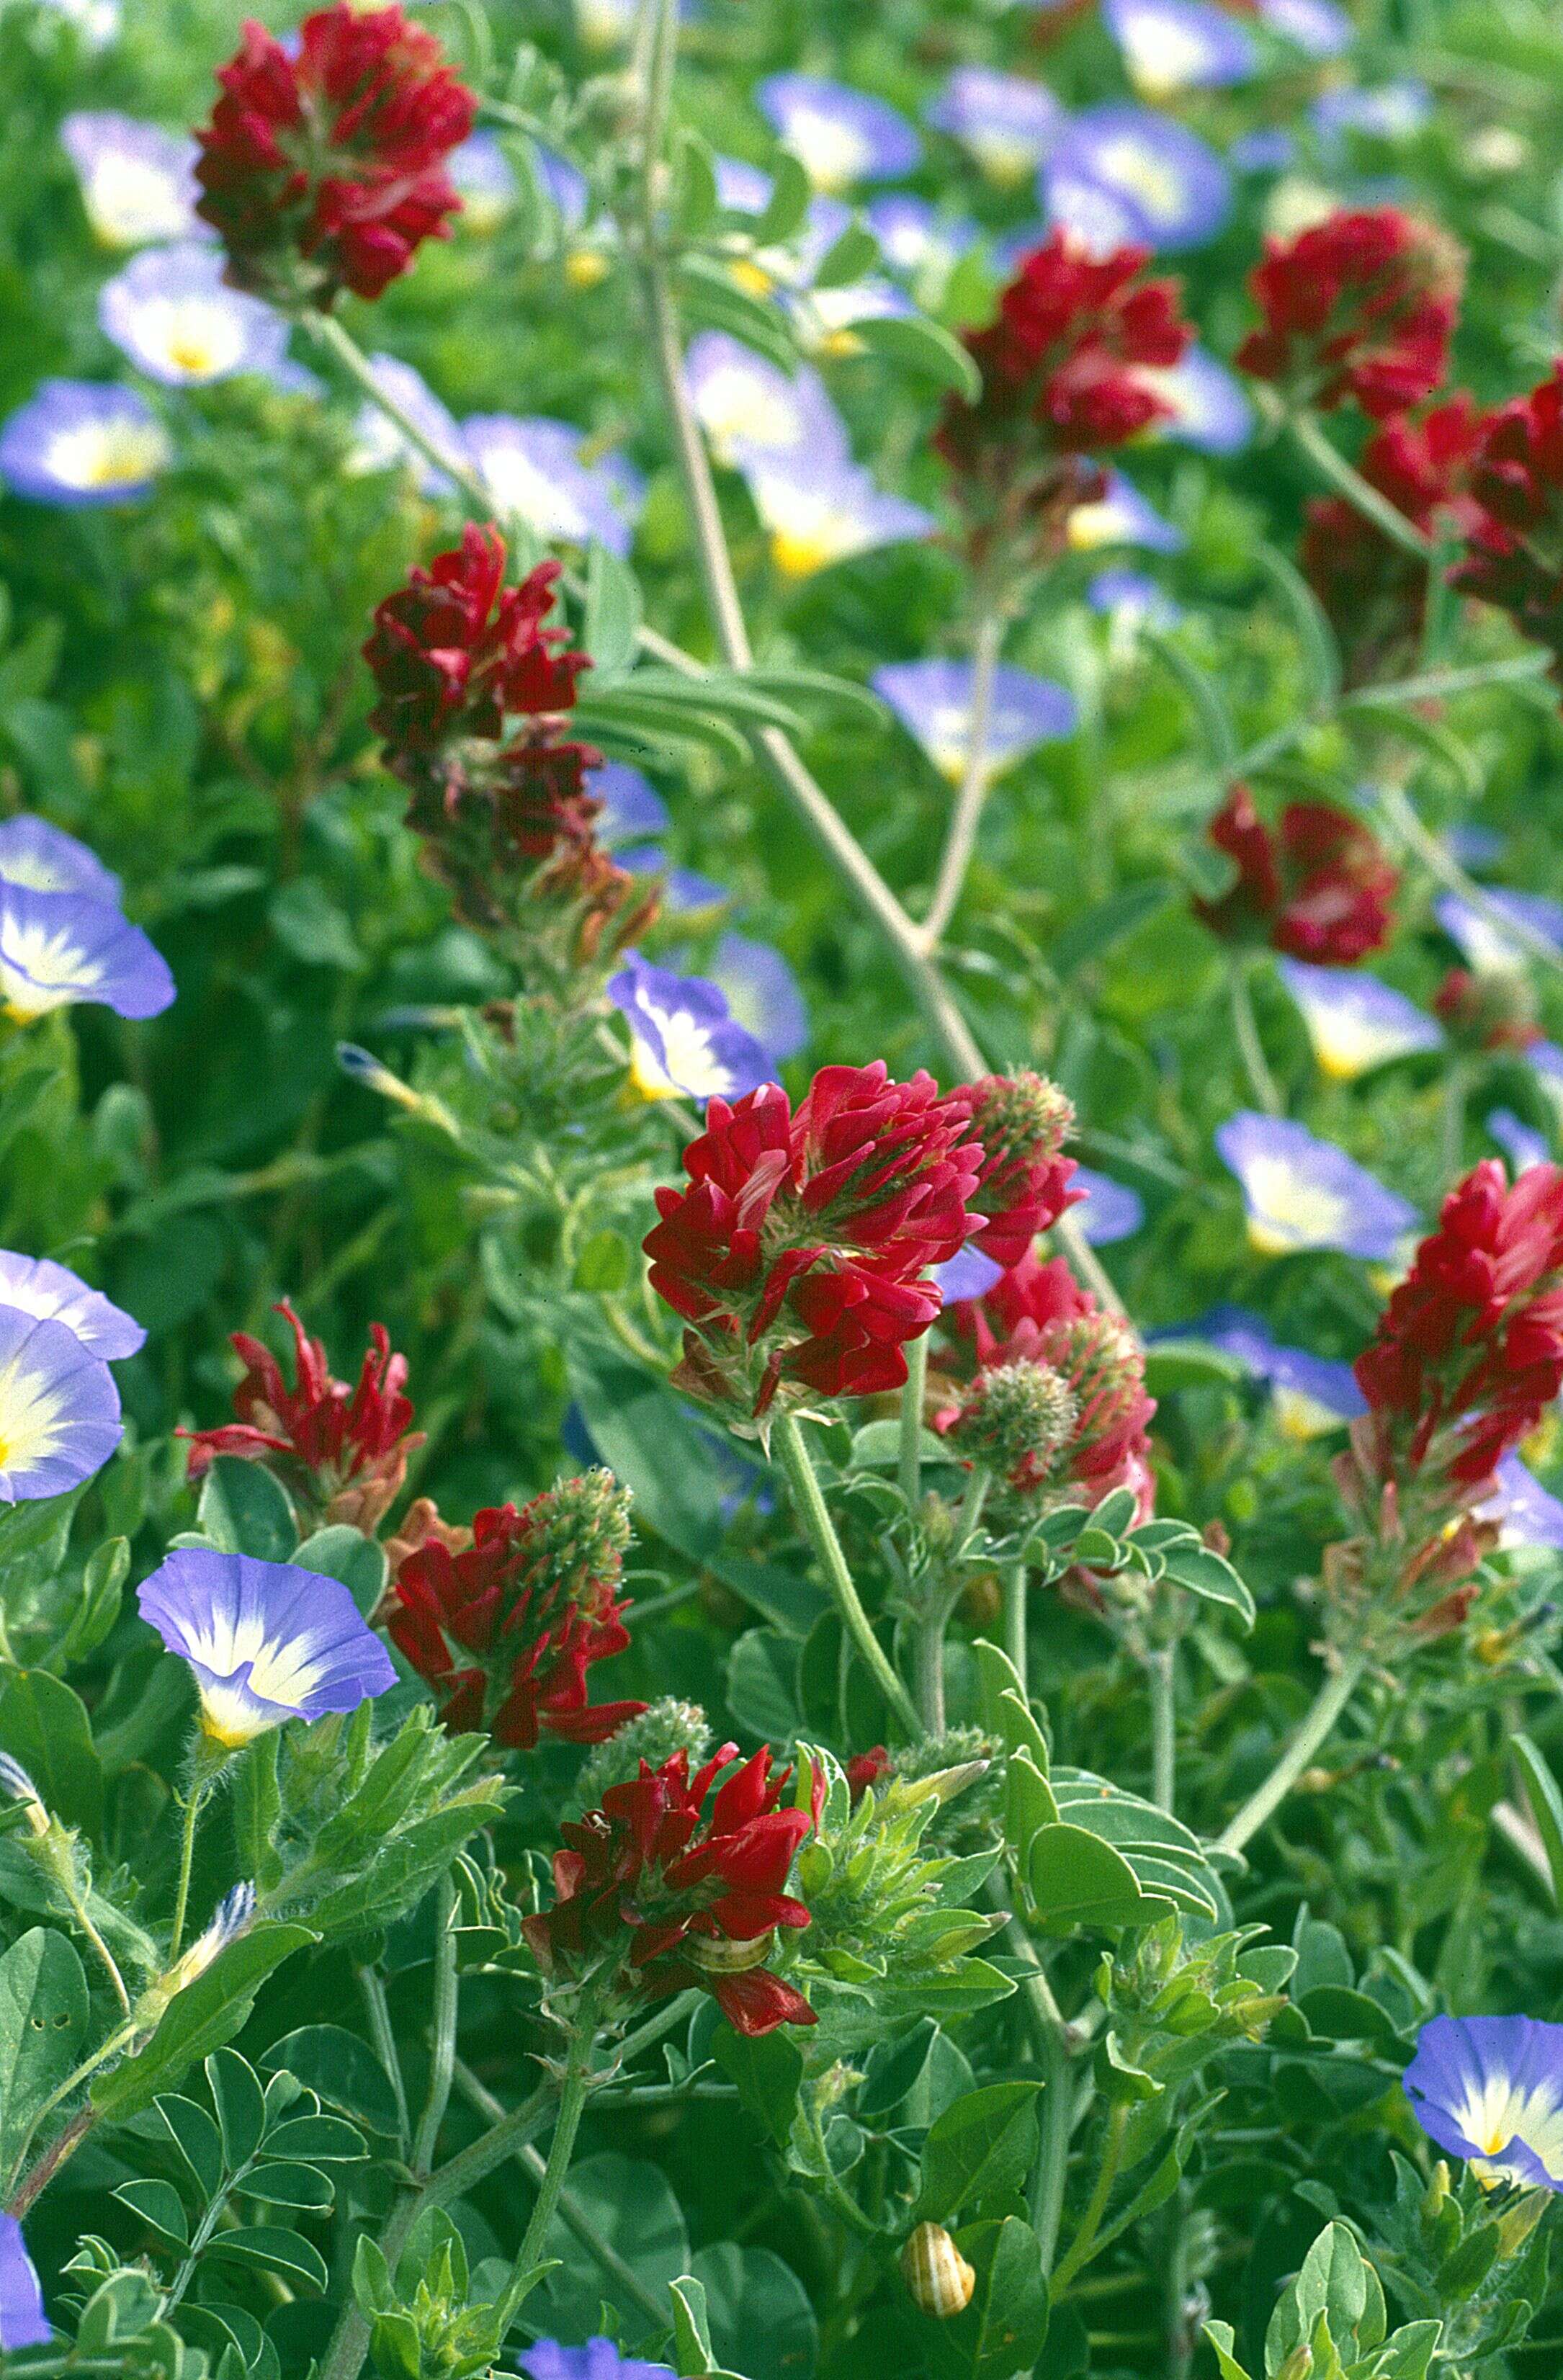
[137,1542,398,1747]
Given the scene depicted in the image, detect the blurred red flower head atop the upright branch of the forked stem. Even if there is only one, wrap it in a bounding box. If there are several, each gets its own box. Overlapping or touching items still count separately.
[935,228,1194,562]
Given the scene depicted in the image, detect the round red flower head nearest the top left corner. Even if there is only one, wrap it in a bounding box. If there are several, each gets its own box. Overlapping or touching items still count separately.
[195,5,478,307]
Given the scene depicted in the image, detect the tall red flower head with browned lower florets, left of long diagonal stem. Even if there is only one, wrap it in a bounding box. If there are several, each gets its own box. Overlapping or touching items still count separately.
[364,524,647,957]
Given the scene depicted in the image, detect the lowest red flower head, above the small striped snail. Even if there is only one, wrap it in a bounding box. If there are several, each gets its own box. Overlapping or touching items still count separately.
[526,1745,816,2035]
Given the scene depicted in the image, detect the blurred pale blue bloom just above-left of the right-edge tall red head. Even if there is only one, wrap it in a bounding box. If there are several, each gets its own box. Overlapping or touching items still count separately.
[1216,1109,1418,1263]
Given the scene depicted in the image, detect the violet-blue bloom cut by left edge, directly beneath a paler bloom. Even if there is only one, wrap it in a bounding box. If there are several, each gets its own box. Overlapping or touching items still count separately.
[0,1305,124,1504]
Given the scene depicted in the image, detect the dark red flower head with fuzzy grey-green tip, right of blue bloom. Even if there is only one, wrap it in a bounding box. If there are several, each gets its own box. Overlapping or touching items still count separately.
[388,1471,645,1752]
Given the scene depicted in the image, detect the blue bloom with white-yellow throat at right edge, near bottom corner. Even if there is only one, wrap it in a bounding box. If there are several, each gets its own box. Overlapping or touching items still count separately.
[1404,2016,1563,2190]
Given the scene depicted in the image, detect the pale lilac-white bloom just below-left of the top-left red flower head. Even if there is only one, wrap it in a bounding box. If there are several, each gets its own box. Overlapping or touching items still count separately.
[97,241,288,388]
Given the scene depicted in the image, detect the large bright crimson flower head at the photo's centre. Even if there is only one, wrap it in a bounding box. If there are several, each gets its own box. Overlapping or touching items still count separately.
[645,1059,982,1414]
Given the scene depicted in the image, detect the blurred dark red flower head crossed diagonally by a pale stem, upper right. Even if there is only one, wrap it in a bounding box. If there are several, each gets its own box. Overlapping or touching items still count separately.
[1299,390,1484,686]
